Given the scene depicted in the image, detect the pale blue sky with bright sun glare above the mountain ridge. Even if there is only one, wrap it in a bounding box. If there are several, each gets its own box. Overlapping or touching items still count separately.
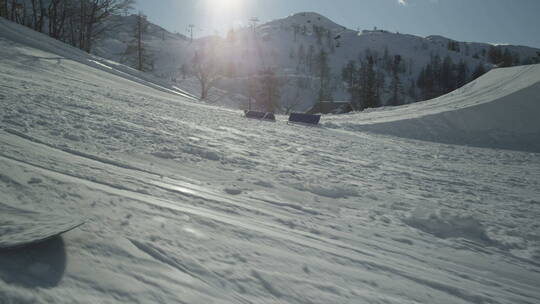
[136,0,540,48]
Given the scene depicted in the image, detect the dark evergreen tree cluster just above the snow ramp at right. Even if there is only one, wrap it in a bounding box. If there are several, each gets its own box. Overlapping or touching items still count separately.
[341,45,487,111]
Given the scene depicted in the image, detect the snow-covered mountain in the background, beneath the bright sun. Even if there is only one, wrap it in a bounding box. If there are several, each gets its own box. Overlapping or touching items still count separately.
[95,12,540,110]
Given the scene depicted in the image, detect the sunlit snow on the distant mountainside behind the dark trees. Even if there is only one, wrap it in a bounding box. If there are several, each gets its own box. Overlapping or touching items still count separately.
[87,12,540,111]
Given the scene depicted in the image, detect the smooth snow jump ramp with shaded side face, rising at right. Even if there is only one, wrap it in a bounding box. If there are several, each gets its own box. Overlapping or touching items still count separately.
[324,65,540,152]
